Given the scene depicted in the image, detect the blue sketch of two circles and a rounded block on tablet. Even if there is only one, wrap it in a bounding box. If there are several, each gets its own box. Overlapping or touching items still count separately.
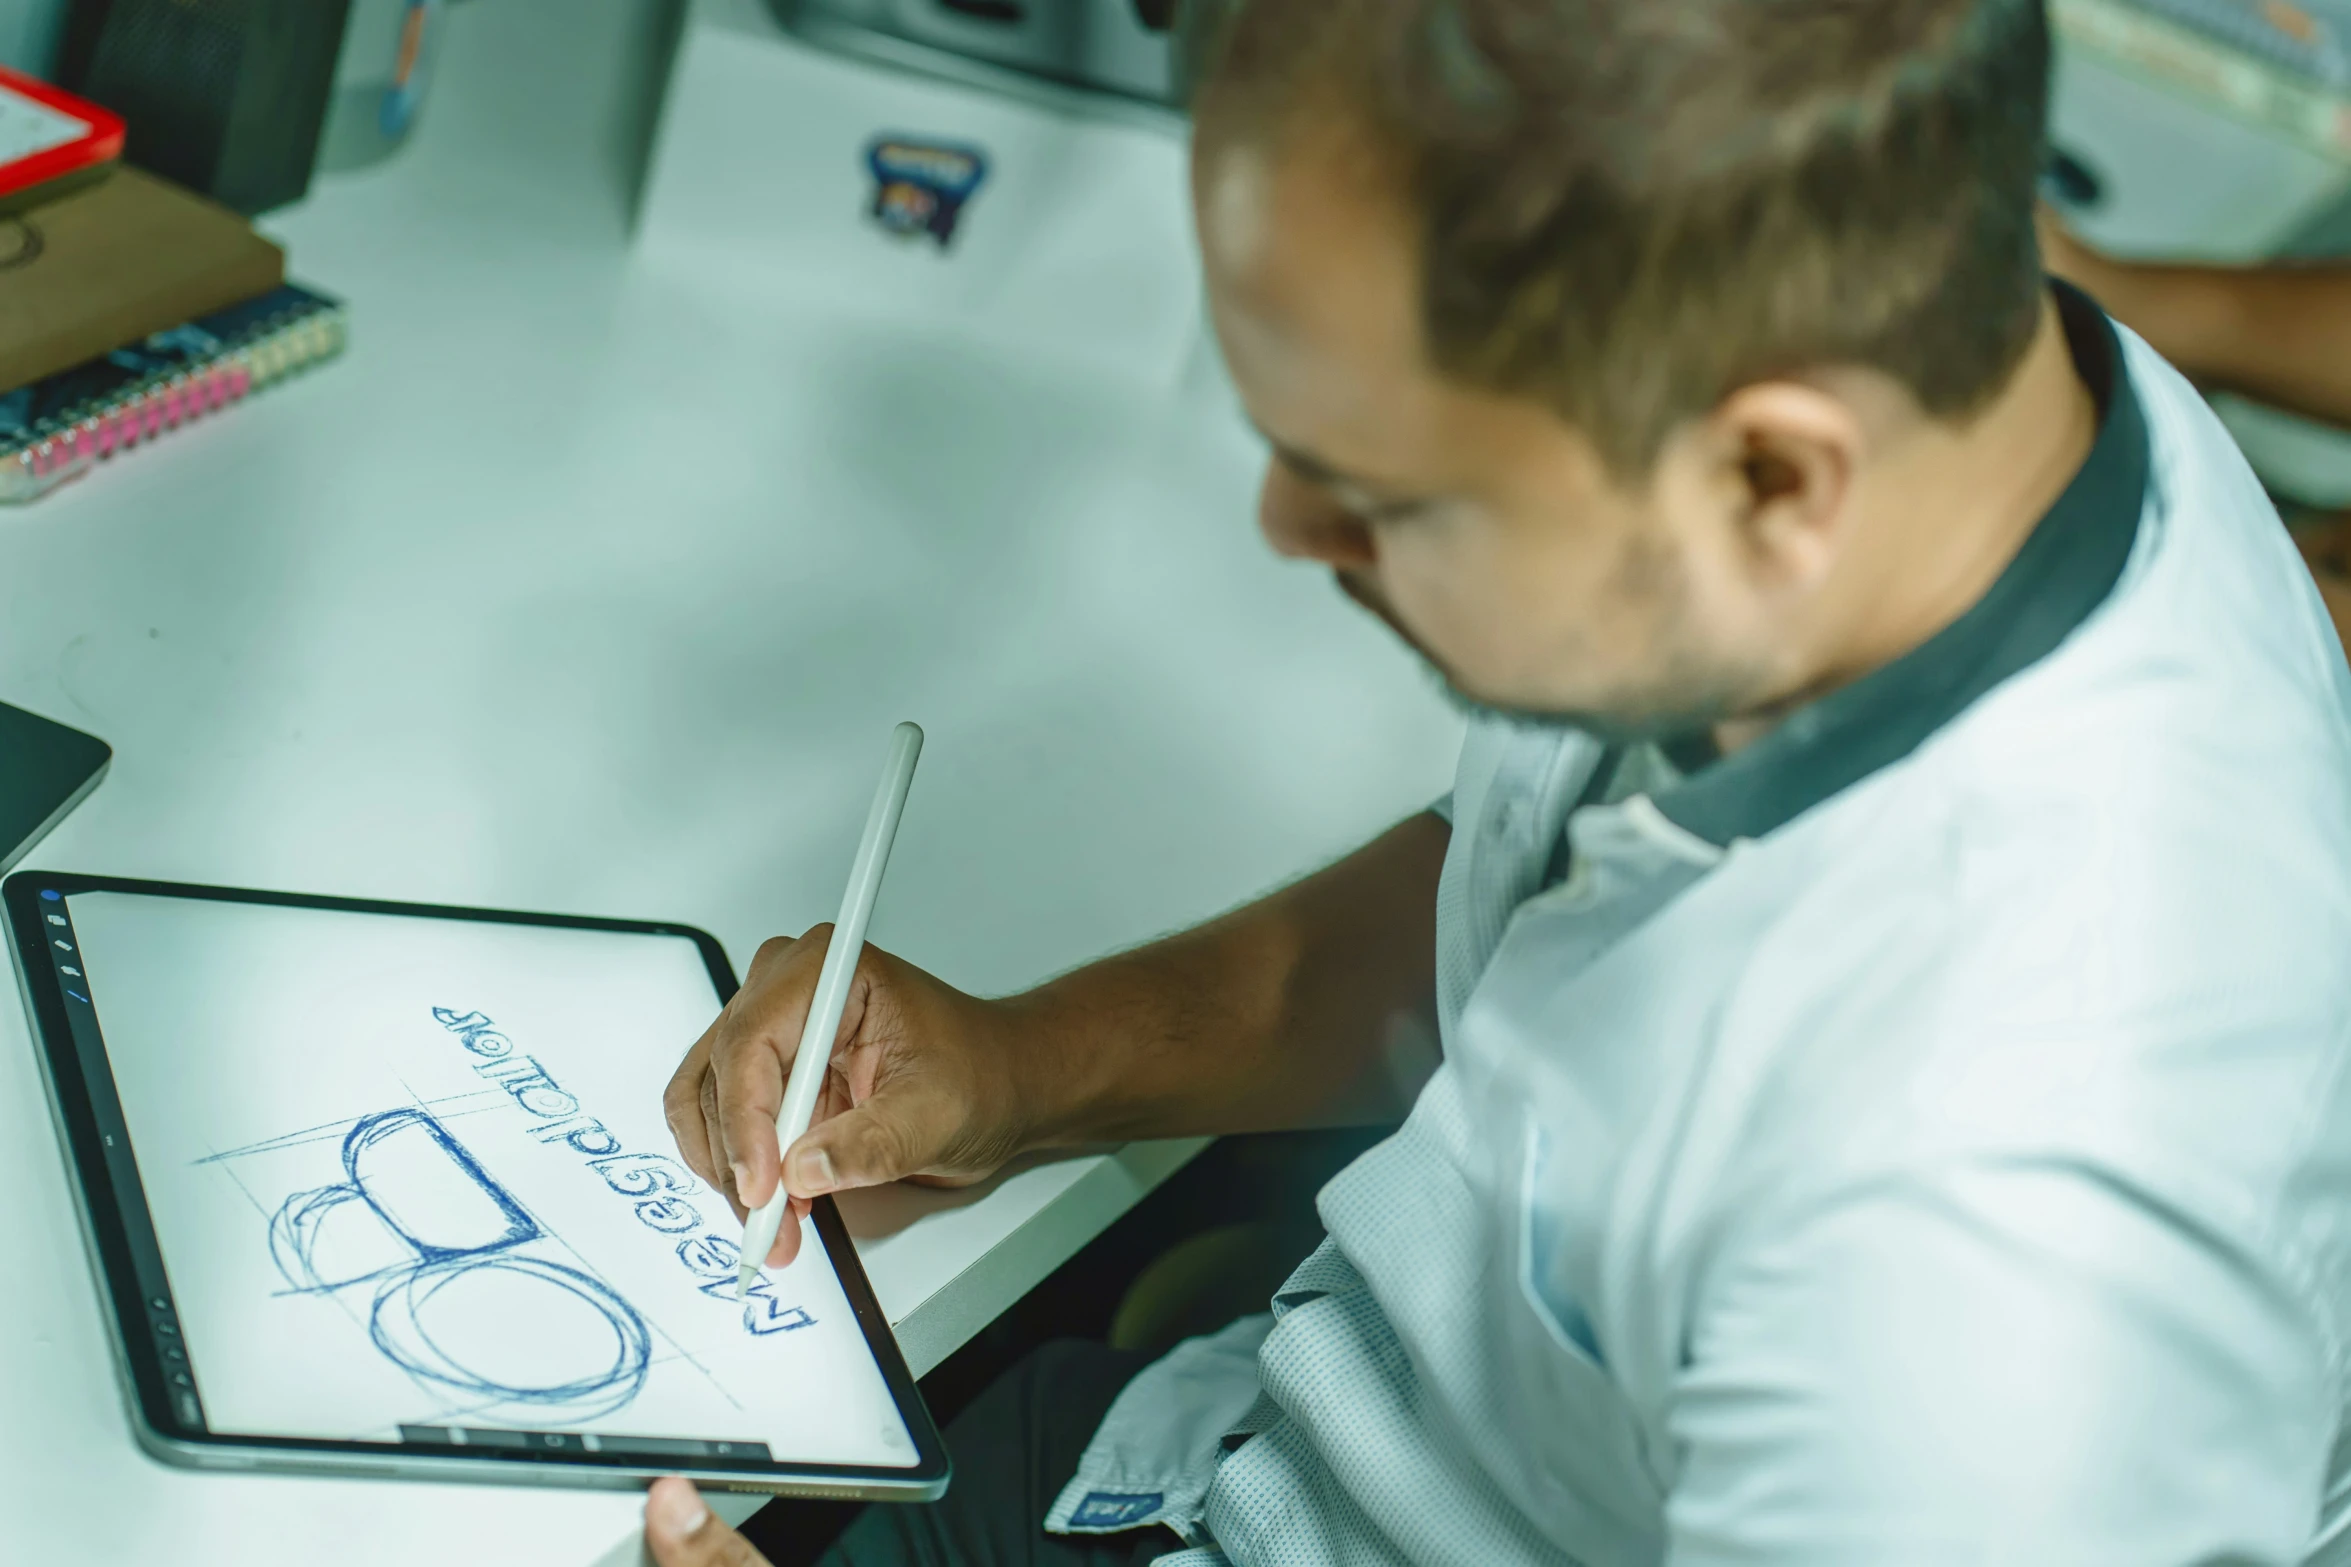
[257,1109,654,1419]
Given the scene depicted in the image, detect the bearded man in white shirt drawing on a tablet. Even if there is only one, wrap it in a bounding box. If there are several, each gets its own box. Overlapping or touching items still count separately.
[647,0,2351,1567]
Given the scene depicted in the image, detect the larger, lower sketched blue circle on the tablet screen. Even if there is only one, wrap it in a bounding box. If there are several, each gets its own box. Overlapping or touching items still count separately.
[369,1257,654,1414]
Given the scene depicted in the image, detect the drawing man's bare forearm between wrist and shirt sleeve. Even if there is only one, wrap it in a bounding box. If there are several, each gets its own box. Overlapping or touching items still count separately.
[1006,815,1451,1146]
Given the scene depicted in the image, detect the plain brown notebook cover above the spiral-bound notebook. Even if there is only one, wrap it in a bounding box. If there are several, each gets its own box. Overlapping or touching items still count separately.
[0,167,287,392]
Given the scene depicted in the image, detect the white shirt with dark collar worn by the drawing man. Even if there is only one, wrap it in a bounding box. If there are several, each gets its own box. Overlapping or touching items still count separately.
[1049,291,2351,1567]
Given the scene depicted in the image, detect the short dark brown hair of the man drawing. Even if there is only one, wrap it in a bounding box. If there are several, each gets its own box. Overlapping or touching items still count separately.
[1192,0,2050,479]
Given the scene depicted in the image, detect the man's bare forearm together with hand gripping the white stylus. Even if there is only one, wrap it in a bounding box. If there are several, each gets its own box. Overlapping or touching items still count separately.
[663,813,1453,1266]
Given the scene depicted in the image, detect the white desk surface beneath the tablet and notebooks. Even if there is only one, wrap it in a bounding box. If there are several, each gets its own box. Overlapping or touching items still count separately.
[0,0,1458,1567]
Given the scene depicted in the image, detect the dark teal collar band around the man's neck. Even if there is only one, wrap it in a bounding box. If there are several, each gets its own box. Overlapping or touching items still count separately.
[1655,282,2149,846]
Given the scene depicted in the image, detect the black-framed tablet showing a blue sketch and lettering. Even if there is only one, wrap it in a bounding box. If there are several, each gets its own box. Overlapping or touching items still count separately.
[0,872,947,1501]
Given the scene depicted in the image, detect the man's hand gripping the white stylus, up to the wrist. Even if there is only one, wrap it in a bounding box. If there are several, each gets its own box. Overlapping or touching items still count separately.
[663,926,1034,1266]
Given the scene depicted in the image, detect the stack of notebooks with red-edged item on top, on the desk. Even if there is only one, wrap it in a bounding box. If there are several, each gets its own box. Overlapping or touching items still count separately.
[0,70,343,503]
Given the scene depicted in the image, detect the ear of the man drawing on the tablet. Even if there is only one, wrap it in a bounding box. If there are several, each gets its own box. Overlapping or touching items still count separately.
[1707,381,1867,590]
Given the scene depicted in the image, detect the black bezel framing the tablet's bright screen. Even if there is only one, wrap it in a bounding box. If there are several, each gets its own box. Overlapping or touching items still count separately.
[0,872,950,1501]
